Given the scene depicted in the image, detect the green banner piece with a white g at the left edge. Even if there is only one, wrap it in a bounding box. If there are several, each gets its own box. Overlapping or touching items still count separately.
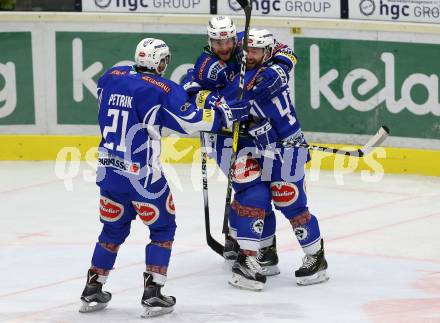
[0,32,35,125]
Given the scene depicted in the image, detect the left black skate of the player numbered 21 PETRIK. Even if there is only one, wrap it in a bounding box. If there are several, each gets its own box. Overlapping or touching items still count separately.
[79,269,112,313]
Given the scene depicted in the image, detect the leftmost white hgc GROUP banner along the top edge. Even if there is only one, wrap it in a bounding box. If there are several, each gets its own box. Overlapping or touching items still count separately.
[82,0,210,14]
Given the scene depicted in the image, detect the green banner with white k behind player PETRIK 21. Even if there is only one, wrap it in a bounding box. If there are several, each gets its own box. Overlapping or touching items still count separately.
[56,32,206,125]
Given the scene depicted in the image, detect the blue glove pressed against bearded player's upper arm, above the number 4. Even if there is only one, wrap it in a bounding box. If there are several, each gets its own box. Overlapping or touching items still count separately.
[252,66,287,104]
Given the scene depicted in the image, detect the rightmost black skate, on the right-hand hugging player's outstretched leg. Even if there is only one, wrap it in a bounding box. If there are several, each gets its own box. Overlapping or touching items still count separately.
[295,239,329,285]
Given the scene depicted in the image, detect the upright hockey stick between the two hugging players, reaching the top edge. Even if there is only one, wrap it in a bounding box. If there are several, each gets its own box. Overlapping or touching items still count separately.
[222,0,252,236]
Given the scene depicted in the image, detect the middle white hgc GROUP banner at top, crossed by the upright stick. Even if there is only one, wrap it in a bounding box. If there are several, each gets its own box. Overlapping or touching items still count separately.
[217,0,341,18]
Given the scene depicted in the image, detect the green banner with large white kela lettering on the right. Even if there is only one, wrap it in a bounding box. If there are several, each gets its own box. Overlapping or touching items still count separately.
[294,37,440,139]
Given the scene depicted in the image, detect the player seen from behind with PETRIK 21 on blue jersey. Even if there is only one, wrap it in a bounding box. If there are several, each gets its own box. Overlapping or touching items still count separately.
[80,38,248,317]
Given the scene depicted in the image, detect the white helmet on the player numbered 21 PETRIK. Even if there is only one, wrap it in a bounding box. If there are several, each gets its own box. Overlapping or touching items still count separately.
[134,38,171,75]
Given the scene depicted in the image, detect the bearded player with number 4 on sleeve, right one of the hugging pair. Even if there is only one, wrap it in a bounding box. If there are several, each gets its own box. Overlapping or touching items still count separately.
[222,29,328,290]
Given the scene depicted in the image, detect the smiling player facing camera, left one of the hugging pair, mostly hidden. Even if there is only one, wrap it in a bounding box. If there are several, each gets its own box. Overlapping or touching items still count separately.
[180,16,297,275]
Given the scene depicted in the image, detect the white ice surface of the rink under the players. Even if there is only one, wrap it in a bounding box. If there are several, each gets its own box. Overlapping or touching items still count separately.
[0,162,440,323]
